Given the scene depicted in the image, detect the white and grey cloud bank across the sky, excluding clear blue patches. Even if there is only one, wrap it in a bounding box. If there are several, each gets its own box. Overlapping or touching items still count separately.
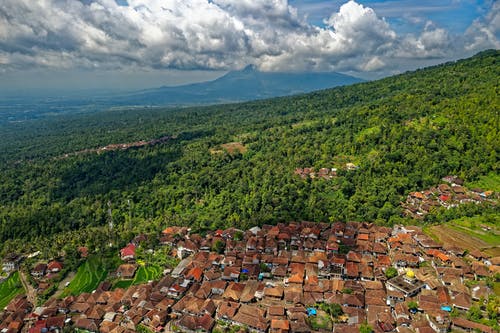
[0,0,500,76]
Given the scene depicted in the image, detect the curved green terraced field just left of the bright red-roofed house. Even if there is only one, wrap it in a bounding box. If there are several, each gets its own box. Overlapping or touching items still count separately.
[61,257,108,298]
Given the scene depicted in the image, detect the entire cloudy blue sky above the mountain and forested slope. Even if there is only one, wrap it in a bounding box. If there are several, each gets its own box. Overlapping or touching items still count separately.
[0,0,500,93]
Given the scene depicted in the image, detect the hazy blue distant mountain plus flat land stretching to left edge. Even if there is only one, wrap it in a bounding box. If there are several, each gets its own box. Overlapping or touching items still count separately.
[0,66,363,123]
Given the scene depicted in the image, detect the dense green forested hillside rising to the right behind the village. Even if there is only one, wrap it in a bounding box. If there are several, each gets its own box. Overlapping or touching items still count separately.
[0,51,500,251]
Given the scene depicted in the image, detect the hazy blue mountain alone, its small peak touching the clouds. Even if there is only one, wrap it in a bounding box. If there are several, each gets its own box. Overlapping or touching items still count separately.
[113,65,363,105]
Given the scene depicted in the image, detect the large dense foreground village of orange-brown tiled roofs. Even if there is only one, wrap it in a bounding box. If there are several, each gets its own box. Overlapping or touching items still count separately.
[0,222,500,333]
